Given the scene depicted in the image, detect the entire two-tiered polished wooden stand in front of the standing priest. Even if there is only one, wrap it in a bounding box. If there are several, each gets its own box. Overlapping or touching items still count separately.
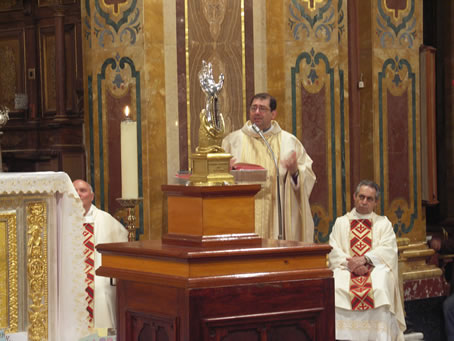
[96,185,335,341]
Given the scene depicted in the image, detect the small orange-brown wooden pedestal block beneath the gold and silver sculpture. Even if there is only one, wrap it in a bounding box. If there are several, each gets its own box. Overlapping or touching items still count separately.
[162,185,260,246]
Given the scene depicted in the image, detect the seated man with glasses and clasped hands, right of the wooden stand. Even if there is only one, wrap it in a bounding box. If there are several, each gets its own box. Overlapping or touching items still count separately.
[329,180,406,341]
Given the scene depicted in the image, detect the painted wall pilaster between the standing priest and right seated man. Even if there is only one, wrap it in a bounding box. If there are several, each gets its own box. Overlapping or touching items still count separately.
[267,0,349,242]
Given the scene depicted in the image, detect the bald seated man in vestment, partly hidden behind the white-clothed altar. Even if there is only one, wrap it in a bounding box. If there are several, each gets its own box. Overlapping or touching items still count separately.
[73,180,128,328]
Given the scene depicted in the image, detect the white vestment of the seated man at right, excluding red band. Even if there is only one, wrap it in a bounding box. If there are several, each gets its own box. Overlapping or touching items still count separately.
[329,209,406,341]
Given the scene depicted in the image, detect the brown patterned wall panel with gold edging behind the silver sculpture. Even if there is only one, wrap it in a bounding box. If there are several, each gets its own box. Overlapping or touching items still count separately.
[177,0,253,169]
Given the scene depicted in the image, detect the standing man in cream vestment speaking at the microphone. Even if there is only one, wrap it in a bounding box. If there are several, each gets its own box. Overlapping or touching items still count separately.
[222,93,315,243]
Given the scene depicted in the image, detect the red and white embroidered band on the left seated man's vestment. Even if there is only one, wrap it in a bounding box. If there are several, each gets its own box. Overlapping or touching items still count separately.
[83,223,95,328]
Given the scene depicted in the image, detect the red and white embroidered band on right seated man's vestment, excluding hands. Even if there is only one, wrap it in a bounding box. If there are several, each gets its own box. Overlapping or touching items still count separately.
[350,219,374,310]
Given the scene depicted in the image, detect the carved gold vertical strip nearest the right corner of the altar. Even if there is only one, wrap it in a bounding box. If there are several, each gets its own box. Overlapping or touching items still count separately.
[27,201,48,341]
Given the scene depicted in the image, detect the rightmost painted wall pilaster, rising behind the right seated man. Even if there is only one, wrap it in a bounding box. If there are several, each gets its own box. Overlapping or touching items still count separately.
[373,0,425,241]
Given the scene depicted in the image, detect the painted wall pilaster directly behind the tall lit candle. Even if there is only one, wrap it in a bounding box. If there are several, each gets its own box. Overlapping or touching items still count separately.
[82,0,167,239]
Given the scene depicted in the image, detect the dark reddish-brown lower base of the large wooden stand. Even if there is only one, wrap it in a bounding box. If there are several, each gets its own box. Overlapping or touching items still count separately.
[113,272,334,341]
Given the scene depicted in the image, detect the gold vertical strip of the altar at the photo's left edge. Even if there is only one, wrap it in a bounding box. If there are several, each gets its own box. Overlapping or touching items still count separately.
[0,211,18,333]
